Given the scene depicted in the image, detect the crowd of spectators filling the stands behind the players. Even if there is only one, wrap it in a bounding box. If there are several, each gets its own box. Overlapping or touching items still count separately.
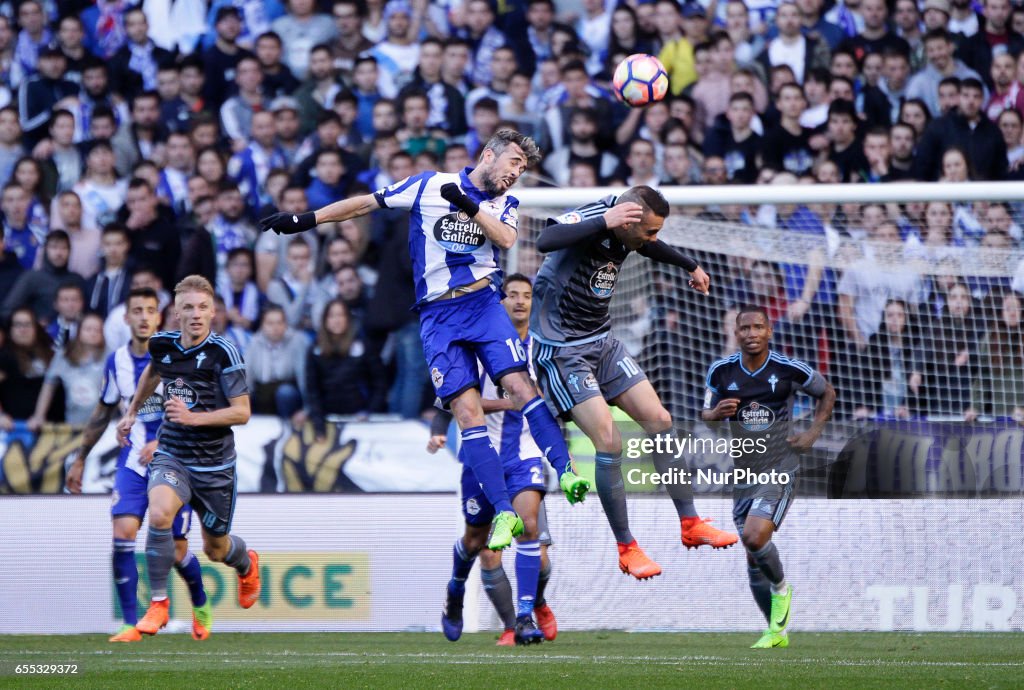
[0,0,1024,440]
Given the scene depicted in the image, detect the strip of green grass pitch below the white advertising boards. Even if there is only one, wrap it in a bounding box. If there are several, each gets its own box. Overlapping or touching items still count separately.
[0,632,1024,690]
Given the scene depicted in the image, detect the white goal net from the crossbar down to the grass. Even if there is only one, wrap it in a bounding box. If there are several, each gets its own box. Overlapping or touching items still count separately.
[450,183,1024,632]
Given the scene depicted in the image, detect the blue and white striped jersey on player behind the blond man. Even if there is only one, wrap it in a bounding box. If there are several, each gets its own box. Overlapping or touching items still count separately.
[102,345,164,477]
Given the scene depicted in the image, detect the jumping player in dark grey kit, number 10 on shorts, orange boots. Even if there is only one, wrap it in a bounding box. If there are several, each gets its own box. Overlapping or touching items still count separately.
[529,186,736,579]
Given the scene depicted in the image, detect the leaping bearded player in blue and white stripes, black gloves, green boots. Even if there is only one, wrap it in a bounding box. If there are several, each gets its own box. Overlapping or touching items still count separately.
[260,129,590,550]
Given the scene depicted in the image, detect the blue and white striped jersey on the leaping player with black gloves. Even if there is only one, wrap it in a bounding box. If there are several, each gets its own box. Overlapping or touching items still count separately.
[374,168,519,305]
